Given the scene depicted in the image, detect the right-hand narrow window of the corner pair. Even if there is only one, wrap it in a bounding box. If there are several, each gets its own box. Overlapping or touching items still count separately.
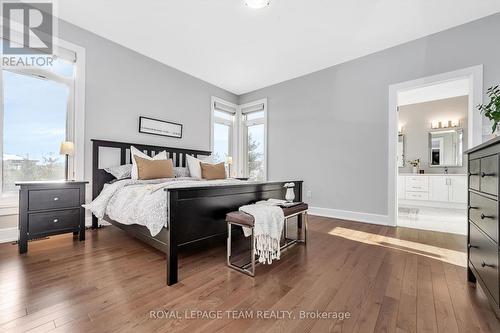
[241,100,267,180]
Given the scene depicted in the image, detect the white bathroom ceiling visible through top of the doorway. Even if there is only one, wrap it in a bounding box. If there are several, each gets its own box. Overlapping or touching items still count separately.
[398,79,470,106]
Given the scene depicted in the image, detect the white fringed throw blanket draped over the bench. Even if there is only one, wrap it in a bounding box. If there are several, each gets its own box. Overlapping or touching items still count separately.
[240,201,285,264]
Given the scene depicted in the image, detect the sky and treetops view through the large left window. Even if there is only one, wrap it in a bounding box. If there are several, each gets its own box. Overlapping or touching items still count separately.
[2,68,69,193]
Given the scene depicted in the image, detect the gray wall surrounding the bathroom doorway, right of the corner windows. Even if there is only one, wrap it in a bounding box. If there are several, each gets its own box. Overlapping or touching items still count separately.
[239,14,500,215]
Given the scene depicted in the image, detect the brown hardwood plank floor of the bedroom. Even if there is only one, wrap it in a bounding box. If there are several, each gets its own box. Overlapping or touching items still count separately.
[0,217,500,332]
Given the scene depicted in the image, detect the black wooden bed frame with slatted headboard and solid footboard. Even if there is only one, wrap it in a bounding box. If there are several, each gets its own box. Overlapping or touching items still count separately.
[92,139,302,285]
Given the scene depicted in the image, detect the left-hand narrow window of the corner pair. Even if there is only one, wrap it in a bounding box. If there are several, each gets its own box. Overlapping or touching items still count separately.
[212,98,237,163]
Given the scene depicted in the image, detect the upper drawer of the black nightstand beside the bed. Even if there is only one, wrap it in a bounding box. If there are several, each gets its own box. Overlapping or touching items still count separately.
[28,188,80,210]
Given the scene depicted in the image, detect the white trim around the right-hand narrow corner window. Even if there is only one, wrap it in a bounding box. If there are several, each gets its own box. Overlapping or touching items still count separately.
[238,98,267,181]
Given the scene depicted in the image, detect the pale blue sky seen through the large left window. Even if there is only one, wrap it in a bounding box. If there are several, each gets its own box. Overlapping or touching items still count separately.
[2,61,73,162]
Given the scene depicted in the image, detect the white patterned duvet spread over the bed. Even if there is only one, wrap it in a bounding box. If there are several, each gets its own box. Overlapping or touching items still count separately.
[84,177,247,236]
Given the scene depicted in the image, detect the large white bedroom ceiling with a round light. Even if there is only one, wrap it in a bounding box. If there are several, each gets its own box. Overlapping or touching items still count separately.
[58,0,500,94]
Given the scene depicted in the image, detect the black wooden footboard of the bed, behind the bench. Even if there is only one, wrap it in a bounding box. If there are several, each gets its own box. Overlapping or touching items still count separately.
[165,181,302,285]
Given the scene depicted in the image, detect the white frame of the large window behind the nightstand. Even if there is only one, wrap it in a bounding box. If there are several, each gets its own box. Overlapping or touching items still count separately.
[0,34,86,210]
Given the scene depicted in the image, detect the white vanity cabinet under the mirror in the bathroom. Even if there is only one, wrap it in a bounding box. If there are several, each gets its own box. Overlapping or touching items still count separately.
[398,174,467,207]
